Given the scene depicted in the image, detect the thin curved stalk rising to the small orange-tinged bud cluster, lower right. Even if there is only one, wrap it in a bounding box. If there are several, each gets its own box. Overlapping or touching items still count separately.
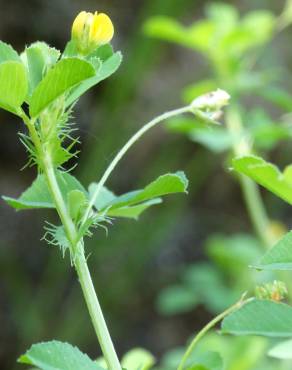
[177,295,252,370]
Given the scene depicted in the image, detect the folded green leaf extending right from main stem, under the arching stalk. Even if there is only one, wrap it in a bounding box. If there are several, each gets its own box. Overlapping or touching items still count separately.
[89,172,188,218]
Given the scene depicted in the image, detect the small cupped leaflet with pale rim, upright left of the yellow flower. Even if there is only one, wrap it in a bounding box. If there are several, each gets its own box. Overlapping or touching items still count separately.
[21,42,61,101]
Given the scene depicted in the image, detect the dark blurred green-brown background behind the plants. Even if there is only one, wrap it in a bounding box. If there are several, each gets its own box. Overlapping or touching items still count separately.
[0,0,292,370]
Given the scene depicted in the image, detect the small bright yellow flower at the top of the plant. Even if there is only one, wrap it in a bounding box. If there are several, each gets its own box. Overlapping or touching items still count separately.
[72,11,114,54]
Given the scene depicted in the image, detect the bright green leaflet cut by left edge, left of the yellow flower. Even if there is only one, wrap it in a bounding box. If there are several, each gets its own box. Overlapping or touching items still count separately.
[0,62,28,115]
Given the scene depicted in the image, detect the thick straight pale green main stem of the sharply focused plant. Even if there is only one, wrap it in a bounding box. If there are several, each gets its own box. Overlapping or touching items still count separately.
[24,117,122,370]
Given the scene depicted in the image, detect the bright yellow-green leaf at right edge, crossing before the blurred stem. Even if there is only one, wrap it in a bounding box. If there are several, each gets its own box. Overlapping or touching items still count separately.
[232,156,292,204]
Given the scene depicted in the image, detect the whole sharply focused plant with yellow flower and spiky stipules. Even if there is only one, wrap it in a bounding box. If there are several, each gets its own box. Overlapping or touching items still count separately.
[0,7,243,370]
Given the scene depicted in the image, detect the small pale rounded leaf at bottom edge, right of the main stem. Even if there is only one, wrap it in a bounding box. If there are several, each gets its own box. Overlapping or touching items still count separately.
[121,348,155,370]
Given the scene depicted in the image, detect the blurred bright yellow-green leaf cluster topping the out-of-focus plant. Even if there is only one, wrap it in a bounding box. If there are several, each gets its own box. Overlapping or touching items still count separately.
[145,3,275,57]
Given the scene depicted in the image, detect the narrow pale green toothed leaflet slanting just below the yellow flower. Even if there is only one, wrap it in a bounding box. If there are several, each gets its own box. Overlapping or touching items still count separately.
[66,52,122,106]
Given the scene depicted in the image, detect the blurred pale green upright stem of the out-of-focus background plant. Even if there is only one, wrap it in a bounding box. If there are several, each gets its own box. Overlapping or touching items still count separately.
[226,105,274,248]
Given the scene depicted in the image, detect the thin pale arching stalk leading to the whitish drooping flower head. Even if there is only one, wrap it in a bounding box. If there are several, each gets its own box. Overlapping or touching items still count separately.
[82,106,194,223]
